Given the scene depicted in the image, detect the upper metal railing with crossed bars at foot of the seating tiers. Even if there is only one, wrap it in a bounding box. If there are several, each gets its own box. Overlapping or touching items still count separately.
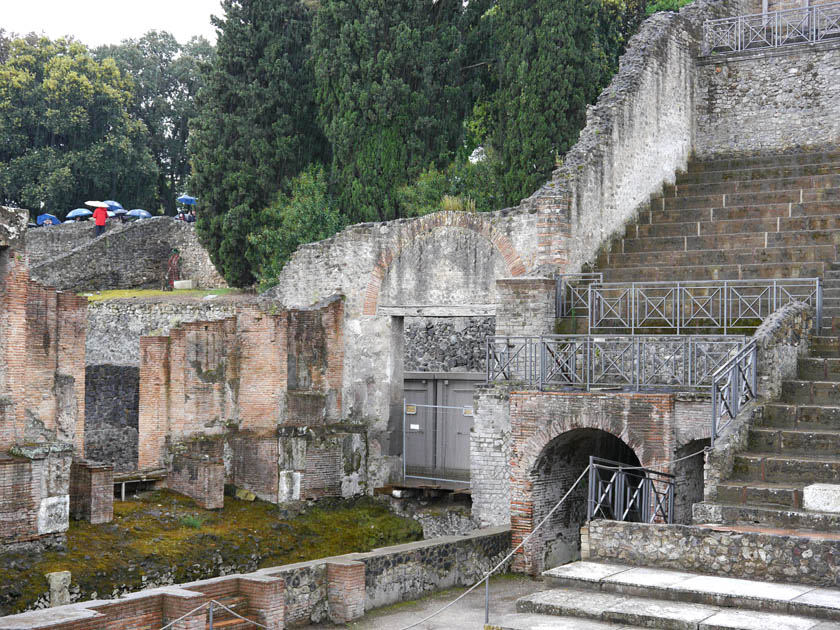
[585,278,822,335]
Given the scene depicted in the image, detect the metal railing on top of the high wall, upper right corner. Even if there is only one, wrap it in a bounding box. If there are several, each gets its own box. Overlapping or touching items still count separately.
[703,2,840,55]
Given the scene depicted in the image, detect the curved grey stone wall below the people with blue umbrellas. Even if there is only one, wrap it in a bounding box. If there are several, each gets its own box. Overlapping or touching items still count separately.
[26,217,226,291]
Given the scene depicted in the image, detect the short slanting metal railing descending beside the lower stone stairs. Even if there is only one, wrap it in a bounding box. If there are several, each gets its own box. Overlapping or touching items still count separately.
[711,340,758,446]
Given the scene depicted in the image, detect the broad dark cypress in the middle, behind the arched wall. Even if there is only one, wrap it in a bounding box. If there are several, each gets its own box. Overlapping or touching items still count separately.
[312,0,468,226]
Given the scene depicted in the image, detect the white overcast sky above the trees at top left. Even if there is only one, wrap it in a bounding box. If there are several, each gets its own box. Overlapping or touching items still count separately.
[0,0,222,48]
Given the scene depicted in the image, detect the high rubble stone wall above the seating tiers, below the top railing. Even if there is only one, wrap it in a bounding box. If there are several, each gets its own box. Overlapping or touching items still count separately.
[695,40,840,158]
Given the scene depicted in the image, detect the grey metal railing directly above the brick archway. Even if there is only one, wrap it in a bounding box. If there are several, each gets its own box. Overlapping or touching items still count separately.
[487,335,746,391]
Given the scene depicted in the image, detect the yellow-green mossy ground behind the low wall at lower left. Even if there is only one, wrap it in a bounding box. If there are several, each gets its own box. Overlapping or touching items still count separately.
[0,490,422,614]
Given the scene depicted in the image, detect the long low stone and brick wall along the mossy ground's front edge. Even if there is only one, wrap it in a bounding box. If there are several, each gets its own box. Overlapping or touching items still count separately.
[0,528,510,630]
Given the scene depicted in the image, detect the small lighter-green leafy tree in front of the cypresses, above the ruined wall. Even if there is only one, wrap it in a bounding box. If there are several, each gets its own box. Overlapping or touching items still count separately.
[248,166,344,288]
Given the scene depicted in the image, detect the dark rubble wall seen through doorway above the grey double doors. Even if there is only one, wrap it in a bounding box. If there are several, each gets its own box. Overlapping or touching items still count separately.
[404,317,496,372]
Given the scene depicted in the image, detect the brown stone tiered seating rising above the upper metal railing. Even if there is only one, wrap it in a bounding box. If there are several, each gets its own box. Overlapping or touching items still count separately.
[596,152,840,282]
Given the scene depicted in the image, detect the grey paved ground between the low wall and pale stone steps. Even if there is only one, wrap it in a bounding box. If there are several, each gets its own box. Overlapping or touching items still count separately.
[306,575,548,630]
